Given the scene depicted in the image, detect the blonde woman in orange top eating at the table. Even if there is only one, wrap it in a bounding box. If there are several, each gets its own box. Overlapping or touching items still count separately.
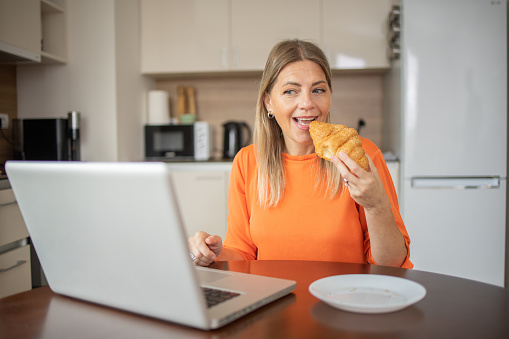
[188,40,413,268]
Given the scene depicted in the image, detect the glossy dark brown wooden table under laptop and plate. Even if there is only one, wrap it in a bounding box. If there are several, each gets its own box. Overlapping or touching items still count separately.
[0,261,509,339]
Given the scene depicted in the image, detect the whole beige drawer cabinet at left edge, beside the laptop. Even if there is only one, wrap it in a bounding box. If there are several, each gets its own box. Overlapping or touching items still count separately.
[0,188,32,298]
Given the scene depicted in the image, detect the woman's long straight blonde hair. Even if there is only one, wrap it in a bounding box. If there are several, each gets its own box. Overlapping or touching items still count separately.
[253,39,342,207]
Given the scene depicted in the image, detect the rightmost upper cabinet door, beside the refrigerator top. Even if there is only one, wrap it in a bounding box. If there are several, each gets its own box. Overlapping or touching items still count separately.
[323,0,392,69]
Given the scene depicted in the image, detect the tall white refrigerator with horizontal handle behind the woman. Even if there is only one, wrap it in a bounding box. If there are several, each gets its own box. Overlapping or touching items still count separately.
[382,0,507,286]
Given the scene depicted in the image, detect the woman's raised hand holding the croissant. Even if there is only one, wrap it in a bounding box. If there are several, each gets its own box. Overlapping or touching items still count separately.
[332,152,390,211]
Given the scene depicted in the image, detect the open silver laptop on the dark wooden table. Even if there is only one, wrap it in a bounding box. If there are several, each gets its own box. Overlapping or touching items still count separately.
[6,161,296,329]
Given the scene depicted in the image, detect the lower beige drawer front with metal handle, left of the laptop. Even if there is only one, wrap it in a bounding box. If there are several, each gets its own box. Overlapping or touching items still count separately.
[0,245,32,298]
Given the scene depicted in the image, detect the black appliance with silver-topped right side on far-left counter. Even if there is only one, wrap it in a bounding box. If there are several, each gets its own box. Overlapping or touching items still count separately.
[12,115,80,161]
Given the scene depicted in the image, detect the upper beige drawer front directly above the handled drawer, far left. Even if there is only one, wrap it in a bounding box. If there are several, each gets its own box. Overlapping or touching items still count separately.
[0,202,28,246]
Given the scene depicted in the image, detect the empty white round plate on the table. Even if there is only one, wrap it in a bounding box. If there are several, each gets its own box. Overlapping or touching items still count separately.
[309,274,426,313]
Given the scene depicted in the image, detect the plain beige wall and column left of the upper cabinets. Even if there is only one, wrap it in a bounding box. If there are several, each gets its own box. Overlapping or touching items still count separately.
[17,0,154,161]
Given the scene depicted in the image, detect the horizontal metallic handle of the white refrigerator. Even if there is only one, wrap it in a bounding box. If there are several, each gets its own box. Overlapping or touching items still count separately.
[411,176,500,189]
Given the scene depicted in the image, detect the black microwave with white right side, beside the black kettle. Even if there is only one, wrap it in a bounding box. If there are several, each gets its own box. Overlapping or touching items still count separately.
[145,121,212,161]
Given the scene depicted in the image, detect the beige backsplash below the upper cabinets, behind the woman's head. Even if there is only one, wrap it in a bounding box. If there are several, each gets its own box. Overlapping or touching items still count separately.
[156,73,383,157]
